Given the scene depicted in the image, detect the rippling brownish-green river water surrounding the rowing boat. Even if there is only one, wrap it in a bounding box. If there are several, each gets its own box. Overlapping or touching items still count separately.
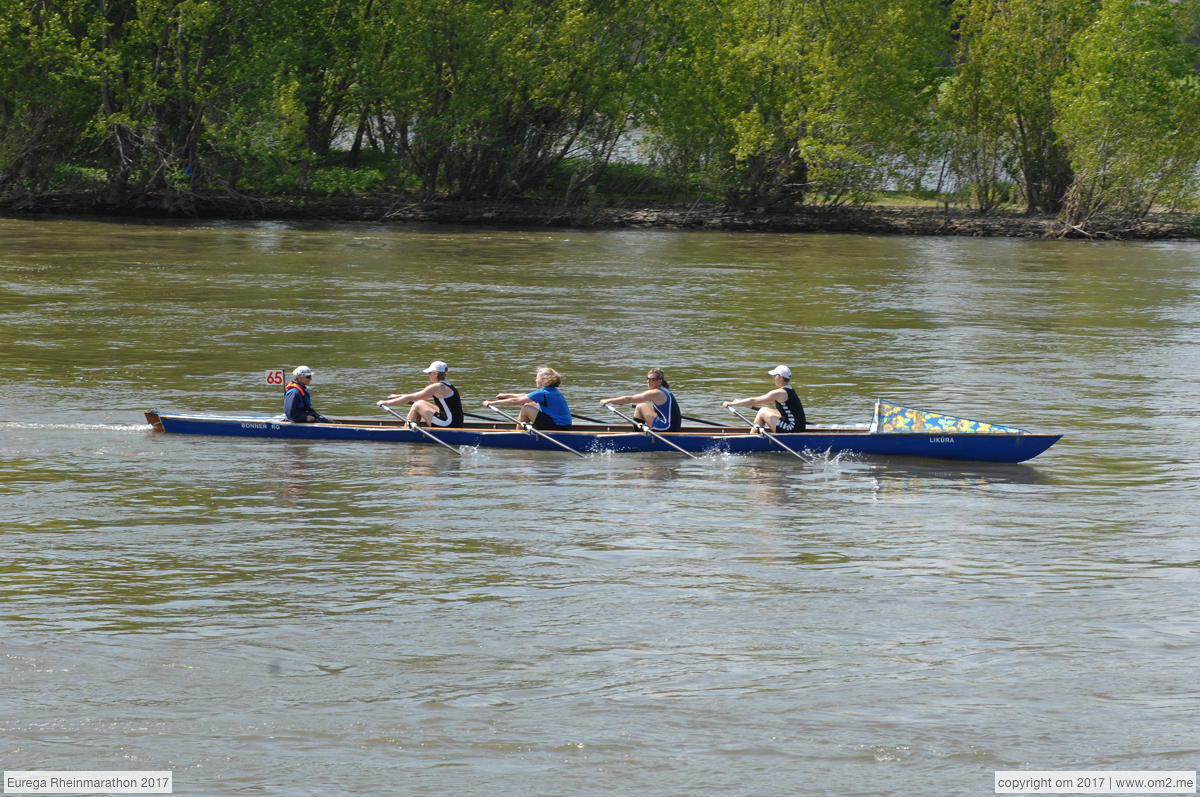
[0,214,1200,796]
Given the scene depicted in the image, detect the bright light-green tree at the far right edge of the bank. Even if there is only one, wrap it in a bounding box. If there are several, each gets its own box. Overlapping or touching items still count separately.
[1054,0,1200,229]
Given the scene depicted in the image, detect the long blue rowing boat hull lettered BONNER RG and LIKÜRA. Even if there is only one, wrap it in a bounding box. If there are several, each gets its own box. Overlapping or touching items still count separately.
[146,411,1062,462]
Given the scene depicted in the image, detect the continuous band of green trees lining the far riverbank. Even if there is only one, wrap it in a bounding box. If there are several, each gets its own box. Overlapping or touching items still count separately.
[0,0,1200,226]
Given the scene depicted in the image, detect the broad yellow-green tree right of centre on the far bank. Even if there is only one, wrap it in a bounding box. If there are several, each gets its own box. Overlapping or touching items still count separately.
[649,0,948,208]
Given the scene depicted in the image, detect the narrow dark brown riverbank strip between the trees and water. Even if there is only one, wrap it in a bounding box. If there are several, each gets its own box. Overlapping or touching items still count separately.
[0,193,1200,240]
